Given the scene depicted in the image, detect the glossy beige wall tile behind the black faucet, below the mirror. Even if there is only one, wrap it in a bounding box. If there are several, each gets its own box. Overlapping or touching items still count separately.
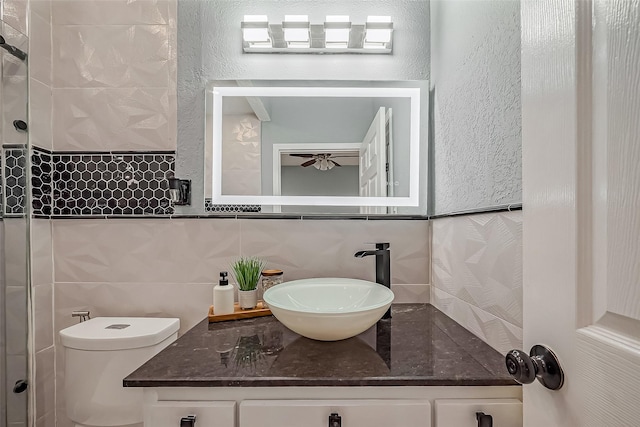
[241,220,429,284]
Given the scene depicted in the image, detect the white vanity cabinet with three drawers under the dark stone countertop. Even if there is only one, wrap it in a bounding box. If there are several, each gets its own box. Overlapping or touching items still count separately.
[144,386,522,427]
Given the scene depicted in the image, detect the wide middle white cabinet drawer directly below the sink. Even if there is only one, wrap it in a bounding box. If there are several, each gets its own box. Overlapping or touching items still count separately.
[240,399,431,427]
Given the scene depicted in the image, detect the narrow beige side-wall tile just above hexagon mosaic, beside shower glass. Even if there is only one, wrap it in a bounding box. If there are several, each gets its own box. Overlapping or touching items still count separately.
[29,78,53,150]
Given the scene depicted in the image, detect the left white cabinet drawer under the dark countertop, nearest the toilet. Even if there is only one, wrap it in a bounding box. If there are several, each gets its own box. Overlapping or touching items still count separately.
[144,401,236,427]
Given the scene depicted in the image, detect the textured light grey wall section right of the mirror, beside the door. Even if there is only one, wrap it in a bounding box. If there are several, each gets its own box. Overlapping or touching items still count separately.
[431,0,522,214]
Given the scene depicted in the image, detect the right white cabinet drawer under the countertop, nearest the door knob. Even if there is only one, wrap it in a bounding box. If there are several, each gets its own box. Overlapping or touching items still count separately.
[434,399,522,427]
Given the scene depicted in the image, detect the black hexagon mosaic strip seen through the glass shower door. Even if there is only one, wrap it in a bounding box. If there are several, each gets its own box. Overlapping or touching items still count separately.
[2,145,27,216]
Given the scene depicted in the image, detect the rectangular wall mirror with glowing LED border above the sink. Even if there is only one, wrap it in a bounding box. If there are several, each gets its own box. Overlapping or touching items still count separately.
[205,81,428,214]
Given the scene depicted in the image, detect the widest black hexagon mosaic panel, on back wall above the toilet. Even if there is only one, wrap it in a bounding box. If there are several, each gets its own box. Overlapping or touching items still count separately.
[52,152,175,215]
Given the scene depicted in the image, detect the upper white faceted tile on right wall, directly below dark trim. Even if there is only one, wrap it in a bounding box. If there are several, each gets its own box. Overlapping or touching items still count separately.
[433,211,522,326]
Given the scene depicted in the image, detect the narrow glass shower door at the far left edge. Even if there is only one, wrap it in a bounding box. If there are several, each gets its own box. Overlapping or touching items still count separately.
[0,21,32,427]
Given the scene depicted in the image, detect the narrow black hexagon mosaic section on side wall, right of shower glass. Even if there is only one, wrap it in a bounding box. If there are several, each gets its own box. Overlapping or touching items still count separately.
[31,147,53,215]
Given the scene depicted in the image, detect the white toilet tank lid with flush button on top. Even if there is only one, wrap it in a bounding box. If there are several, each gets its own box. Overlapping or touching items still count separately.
[60,317,180,351]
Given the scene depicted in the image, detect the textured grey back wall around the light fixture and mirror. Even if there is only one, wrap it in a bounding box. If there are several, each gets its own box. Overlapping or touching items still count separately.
[176,0,429,213]
